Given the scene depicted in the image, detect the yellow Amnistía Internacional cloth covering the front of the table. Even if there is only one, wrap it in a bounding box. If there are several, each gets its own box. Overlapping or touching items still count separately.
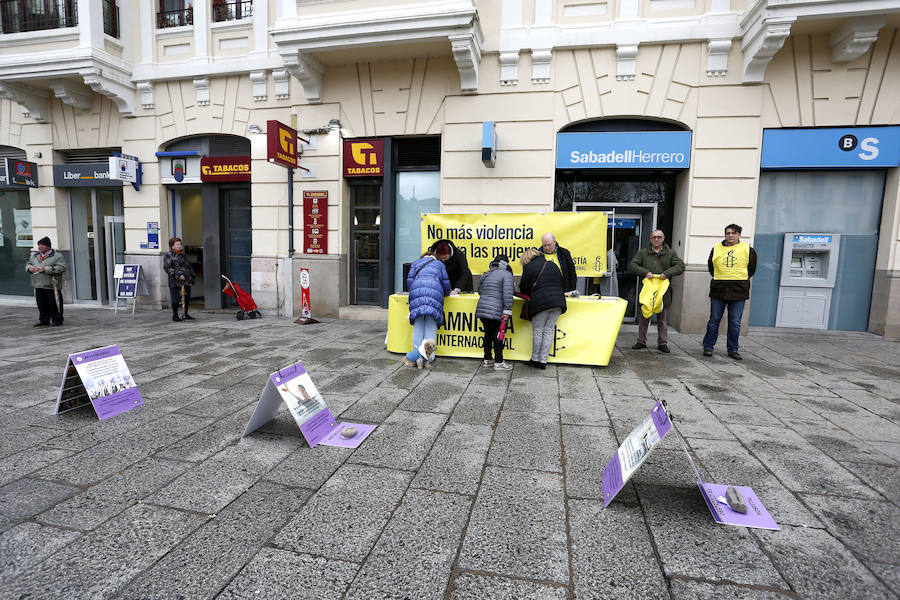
[387,294,628,367]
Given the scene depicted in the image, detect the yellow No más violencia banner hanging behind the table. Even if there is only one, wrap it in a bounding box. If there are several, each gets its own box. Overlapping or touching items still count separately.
[422,212,607,277]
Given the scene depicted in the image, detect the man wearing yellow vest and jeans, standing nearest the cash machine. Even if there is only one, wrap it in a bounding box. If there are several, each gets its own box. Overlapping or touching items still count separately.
[703,223,756,360]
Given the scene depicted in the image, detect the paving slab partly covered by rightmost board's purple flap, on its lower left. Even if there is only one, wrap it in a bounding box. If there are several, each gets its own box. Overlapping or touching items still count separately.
[636,486,788,589]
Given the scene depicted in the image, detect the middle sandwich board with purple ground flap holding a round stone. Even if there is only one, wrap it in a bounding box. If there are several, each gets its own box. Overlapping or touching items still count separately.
[241,362,375,448]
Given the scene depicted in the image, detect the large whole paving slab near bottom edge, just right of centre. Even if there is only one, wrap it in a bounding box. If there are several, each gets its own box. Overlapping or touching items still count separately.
[458,467,570,584]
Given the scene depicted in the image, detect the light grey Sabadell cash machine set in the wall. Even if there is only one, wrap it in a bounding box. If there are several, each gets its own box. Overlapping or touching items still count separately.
[775,233,841,329]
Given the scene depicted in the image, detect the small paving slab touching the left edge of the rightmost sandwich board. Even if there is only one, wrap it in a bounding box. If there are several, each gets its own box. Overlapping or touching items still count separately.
[563,425,624,499]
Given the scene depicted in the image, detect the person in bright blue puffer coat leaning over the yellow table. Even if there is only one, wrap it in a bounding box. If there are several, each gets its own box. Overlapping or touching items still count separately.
[403,251,451,369]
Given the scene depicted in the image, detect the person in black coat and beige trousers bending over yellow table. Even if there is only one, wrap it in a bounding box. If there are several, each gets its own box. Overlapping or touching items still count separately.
[519,248,566,369]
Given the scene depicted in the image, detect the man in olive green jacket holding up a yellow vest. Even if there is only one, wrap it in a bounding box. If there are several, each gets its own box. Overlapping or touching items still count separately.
[628,229,684,354]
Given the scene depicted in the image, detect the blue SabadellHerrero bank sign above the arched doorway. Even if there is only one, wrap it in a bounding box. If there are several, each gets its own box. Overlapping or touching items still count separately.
[556,131,691,169]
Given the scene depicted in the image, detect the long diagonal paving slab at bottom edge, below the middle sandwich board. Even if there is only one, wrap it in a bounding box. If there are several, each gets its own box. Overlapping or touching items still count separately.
[122,483,310,600]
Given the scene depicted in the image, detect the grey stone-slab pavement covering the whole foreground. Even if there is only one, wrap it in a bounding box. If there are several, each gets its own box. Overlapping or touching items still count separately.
[0,305,900,600]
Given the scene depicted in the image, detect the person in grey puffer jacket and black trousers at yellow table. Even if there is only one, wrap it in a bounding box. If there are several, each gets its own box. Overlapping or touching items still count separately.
[475,254,516,371]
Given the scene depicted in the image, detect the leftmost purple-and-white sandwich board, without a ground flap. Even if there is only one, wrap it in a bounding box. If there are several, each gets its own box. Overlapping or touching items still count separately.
[56,346,144,421]
